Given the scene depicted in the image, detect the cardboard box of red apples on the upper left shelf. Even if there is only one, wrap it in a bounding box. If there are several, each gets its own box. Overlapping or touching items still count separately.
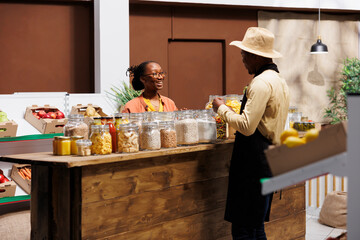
[25,105,67,133]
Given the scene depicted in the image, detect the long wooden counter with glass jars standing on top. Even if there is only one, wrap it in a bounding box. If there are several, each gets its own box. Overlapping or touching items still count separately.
[2,140,305,240]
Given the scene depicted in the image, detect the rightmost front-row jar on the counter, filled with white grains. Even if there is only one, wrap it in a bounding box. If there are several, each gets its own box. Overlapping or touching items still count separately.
[196,110,216,143]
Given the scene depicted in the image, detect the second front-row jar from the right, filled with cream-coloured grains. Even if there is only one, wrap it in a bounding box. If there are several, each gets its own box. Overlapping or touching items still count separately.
[175,111,199,145]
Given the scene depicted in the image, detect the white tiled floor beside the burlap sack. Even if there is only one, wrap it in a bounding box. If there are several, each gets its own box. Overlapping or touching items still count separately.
[305,208,346,240]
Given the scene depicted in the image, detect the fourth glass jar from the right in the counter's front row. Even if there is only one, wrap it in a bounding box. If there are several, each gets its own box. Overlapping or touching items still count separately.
[140,122,161,150]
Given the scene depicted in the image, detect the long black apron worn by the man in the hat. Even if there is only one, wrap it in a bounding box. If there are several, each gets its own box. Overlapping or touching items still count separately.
[225,65,277,228]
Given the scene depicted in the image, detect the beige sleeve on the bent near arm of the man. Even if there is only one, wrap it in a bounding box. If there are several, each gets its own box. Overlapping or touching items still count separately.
[217,81,271,136]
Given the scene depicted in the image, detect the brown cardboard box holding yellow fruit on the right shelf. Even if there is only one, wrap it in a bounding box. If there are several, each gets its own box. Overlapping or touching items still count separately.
[265,122,347,176]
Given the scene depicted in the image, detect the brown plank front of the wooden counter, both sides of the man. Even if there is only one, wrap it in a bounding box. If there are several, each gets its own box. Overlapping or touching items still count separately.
[81,144,305,240]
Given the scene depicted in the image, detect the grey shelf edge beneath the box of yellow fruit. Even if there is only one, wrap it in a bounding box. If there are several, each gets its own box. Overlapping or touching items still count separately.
[261,152,347,195]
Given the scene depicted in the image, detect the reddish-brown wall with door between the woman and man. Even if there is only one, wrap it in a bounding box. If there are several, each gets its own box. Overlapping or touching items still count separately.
[131,4,257,109]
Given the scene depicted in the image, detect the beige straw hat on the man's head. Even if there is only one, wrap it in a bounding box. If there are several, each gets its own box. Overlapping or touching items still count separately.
[230,27,282,58]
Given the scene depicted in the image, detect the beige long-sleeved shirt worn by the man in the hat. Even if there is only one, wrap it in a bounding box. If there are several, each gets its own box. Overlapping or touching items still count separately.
[217,70,289,144]
